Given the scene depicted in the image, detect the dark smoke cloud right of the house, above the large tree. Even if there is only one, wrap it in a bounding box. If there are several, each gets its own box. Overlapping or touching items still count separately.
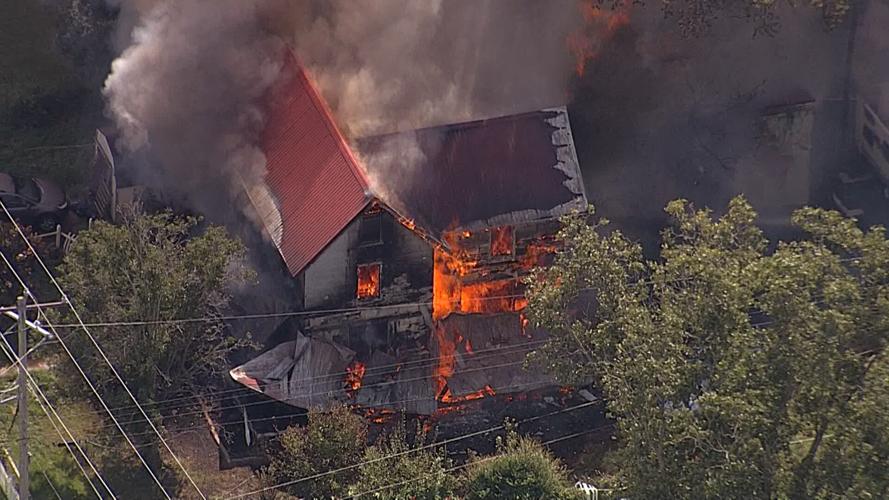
[569,1,849,248]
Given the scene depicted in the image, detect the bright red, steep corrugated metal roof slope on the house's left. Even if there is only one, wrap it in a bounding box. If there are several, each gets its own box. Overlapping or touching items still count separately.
[262,51,370,276]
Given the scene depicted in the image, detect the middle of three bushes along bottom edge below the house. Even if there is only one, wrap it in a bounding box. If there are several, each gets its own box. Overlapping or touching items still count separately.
[352,424,456,500]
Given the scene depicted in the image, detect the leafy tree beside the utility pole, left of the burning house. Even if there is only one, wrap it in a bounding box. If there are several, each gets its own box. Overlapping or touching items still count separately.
[60,213,250,428]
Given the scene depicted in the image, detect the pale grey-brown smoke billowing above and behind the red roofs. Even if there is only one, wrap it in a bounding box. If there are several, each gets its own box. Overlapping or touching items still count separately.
[105,0,581,225]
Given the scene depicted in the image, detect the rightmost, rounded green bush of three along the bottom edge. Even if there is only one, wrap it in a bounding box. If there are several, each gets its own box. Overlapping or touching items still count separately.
[463,431,580,500]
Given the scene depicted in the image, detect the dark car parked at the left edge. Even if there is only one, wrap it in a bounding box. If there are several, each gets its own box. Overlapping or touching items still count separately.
[0,173,68,231]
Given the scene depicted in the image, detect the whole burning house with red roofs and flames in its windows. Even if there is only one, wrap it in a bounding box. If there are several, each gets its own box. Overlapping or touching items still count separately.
[231,51,587,415]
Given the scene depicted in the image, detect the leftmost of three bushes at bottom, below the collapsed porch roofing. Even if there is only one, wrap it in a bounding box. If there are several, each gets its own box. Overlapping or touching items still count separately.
[263,407,367,498]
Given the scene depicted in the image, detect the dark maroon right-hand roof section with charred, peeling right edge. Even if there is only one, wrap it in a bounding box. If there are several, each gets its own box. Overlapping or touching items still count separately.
[356,107,587,236]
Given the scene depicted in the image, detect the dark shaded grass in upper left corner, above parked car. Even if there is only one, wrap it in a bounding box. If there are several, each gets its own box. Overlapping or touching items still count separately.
[0,0,102,190]
